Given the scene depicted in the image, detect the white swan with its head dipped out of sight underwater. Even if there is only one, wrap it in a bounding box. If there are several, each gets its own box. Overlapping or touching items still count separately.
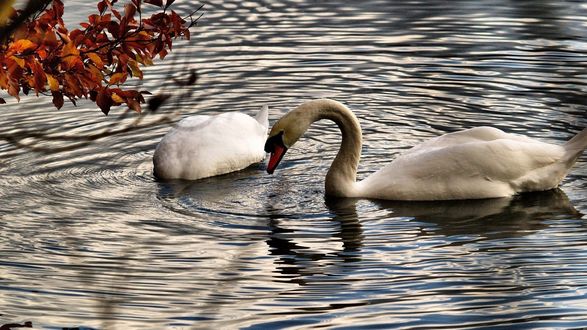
[153,106,269,180]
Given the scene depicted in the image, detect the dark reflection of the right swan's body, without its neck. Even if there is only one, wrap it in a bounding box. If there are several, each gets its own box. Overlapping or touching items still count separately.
[373,189,582,238]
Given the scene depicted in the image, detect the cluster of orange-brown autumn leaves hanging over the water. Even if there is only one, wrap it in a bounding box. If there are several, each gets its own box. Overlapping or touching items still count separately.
[0,0,201,114]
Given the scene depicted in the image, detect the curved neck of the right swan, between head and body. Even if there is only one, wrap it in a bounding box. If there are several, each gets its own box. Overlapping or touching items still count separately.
[298,100,362,197]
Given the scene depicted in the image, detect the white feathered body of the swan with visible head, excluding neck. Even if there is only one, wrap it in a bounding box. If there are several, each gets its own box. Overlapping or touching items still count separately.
[359,127,576,200]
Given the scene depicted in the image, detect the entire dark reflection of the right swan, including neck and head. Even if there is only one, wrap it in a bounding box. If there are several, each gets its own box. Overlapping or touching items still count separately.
[267,189,582,284]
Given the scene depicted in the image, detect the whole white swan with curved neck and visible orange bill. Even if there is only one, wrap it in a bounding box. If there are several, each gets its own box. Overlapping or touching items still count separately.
[265,99,587,200]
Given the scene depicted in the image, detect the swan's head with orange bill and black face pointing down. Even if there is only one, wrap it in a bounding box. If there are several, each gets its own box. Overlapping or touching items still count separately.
[265,107,312,174]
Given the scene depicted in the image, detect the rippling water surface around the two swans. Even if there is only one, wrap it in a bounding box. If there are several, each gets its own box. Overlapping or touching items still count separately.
[0,0,587,329]
